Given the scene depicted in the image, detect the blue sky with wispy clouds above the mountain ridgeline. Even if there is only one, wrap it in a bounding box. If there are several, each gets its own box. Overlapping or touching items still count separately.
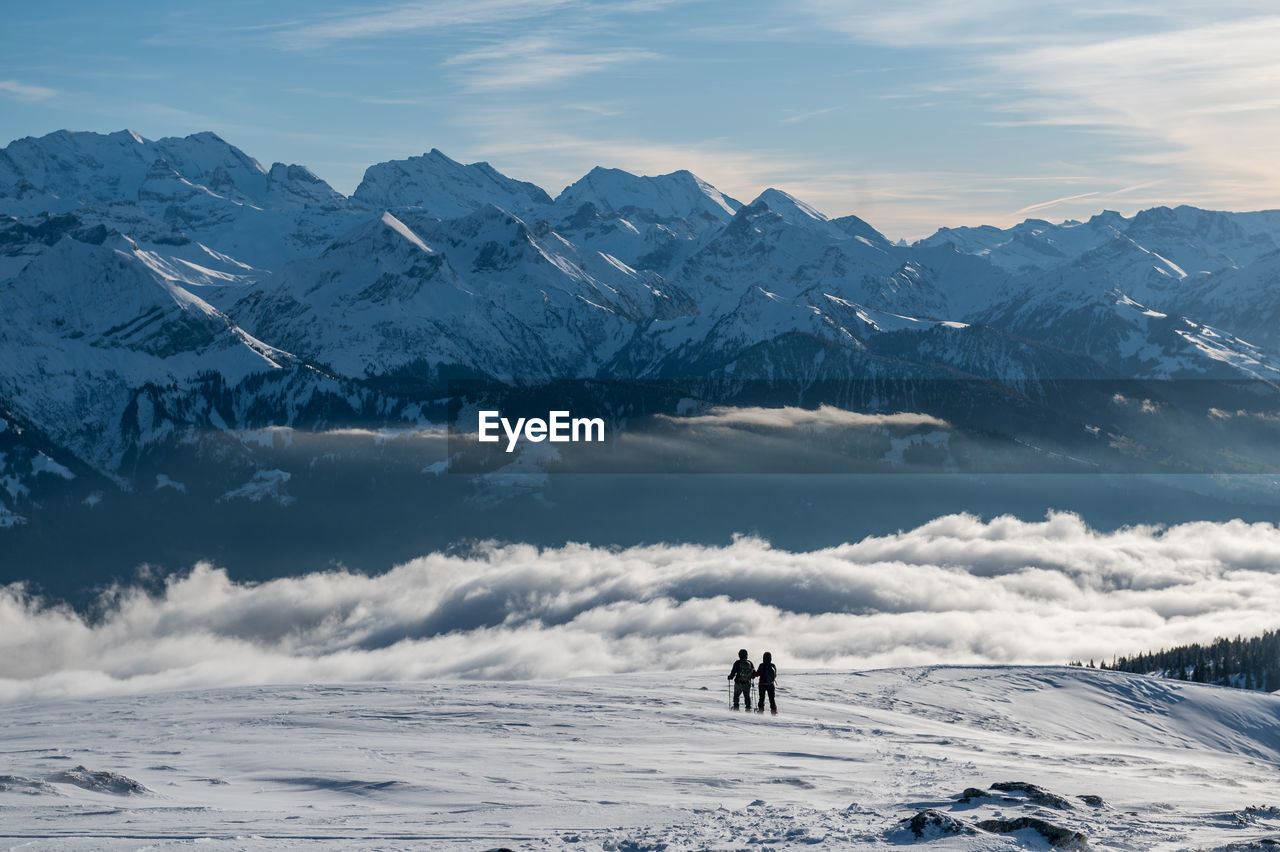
[0,0,1280,237]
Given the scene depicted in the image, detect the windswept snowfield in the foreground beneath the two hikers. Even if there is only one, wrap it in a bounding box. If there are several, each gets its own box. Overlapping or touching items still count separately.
[0,655,1280,851]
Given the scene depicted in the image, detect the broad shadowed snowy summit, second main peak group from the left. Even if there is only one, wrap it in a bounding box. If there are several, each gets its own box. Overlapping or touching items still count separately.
[352,148,552,219]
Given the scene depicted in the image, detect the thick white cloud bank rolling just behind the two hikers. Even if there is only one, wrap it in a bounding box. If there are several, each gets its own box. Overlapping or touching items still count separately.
[0,514,1280,701]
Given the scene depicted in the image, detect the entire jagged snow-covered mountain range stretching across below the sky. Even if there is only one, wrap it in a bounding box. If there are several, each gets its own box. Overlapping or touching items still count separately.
[0,130,1280,526]
